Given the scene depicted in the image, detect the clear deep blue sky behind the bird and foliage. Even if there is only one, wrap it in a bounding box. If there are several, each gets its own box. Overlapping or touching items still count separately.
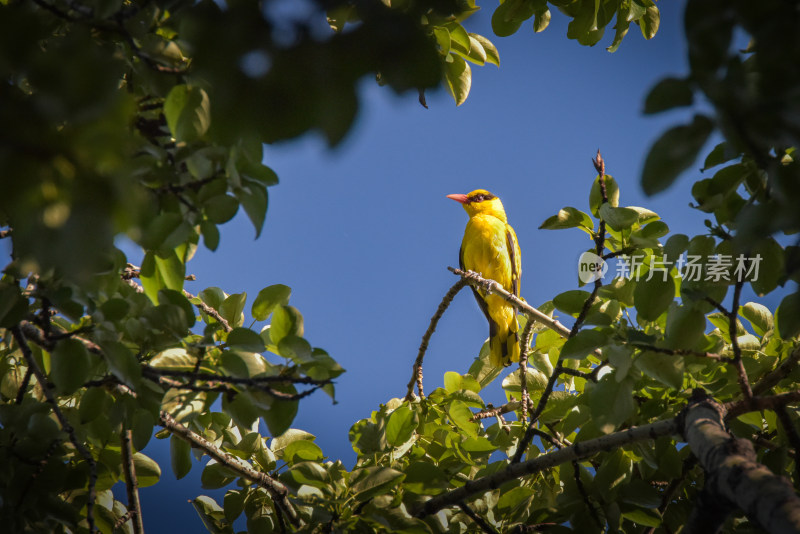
[108,2,788,533]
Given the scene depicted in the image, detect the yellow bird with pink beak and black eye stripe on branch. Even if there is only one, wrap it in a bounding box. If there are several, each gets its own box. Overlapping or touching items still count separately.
[447,189,522,366]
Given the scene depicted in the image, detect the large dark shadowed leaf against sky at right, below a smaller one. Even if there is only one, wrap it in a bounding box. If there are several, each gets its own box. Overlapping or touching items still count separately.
[642,115,714,195]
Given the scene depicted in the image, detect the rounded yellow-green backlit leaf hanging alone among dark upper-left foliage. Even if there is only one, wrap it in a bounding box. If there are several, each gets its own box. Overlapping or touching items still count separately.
[164,85,211,142]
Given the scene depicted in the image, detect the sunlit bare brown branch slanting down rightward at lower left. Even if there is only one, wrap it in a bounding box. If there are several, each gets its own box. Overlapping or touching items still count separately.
[159,410,299,526]
